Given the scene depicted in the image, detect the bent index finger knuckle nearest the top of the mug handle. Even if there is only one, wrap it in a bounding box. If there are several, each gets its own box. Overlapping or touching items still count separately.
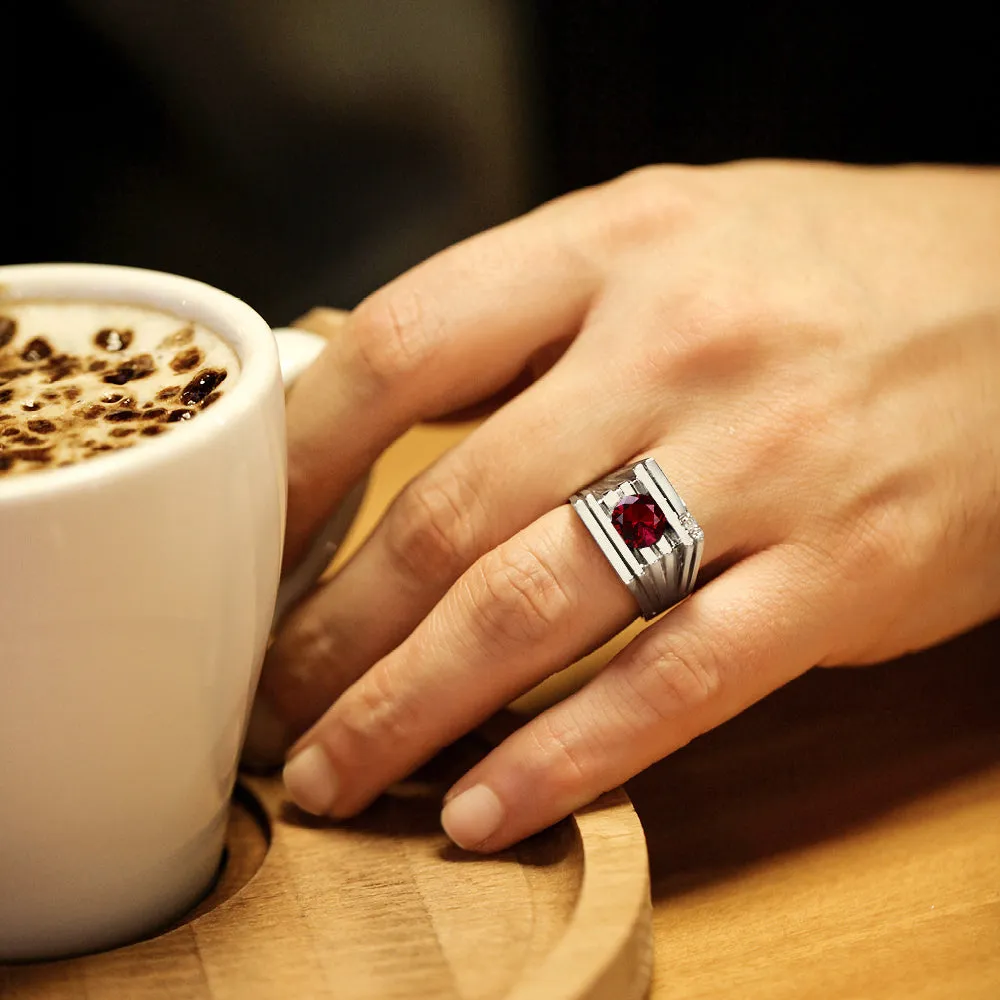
[351,286,435,387]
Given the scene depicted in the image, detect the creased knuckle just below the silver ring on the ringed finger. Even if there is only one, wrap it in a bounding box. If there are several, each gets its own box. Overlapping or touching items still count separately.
[472,542,573,645]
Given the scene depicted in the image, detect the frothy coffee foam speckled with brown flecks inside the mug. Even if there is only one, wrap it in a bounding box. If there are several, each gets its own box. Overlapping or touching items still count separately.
[0,300,239,477]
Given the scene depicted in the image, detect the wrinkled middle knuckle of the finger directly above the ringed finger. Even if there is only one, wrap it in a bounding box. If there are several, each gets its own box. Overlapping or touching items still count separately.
[386,476,478,585]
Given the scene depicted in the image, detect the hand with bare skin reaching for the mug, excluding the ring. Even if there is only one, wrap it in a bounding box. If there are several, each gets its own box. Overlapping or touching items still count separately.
[250,162,1000,851]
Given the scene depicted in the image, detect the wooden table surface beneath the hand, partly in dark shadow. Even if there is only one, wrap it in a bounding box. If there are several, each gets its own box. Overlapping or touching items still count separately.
[356,427,1000,1000]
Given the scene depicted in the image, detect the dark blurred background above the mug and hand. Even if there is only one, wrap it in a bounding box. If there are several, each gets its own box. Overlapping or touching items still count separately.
[7,0,1000,323]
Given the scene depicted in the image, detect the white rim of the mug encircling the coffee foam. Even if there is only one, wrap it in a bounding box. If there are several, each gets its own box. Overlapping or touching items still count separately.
[0,262,280,507]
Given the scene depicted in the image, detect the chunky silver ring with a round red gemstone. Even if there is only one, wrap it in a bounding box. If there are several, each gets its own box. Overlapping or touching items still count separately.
[569,458,705,621]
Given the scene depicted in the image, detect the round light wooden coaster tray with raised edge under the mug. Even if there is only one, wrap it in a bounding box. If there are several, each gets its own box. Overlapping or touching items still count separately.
[0,734,652,1000]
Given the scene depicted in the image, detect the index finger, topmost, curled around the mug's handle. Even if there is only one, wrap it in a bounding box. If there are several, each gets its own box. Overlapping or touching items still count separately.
[286,206,597,562]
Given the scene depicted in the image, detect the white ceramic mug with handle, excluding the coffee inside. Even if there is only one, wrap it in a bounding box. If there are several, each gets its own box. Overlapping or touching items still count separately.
[0,264,360,960]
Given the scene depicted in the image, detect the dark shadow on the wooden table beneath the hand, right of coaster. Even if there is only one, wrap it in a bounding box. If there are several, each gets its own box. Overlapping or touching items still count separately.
[627,621,1000,899]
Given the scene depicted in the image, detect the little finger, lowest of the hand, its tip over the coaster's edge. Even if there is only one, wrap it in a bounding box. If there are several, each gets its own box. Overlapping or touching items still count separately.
[442,547,839,851]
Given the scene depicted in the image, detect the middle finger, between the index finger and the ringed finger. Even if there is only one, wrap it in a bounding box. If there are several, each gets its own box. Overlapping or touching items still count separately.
[247,367,640,762]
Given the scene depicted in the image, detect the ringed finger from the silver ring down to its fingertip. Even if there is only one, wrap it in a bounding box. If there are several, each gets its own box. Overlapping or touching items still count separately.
[285,480,740,815]
